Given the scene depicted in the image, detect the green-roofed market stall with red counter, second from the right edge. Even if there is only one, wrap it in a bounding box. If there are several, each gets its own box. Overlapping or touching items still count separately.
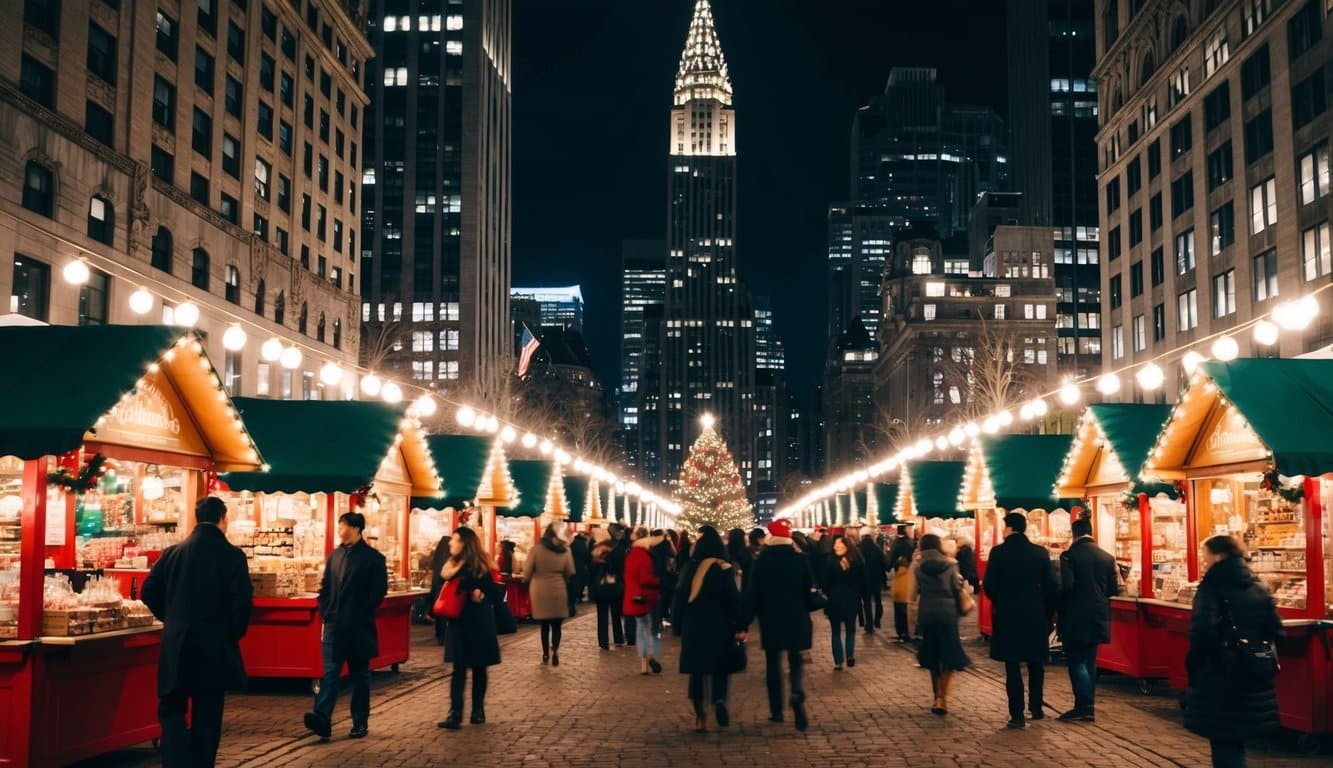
[1054,403,1184,692]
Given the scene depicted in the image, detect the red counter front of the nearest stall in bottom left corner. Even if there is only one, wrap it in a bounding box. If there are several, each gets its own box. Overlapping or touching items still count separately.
[0,624,161,768]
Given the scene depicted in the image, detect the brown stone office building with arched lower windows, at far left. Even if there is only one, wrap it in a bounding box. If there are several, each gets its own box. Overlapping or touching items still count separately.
[0,0,372,397]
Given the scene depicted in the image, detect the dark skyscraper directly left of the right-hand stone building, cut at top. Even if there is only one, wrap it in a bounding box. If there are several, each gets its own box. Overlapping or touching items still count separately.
[1006,0,1101,376]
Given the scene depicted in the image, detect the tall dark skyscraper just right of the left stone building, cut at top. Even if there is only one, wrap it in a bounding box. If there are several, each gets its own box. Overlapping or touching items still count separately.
[361,0,512,388]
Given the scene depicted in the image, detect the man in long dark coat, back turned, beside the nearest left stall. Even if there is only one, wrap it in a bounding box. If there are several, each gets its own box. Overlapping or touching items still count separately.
[143,496,255,768]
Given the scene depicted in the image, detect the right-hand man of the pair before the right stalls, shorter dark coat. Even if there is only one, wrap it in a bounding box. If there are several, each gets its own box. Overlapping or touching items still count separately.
[1060,517,1120,723]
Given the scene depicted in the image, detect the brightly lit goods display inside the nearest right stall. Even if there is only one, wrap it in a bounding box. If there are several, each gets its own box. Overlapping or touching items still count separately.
[1194,472,1306,609]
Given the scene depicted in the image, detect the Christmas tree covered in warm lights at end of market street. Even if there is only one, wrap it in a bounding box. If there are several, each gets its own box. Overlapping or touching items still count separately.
[676,415,754,536]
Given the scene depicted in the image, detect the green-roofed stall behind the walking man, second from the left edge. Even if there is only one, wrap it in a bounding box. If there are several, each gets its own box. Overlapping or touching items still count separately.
[221,397,440,684]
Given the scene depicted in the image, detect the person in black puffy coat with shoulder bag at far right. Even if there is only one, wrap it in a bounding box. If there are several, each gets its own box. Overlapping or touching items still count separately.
[1185,536,1282,768]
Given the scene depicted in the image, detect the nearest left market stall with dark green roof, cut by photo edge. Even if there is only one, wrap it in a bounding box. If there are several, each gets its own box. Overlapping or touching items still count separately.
[0,325,261,765]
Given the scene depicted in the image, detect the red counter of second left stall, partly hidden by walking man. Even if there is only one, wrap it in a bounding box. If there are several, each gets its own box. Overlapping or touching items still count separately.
[241,589,427,684]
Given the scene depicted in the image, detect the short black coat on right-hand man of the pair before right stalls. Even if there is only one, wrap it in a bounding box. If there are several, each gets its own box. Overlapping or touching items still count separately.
[1060,536,1120,645]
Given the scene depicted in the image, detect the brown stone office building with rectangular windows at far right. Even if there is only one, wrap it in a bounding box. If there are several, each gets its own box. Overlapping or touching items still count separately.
[1093,0,1333,400]
